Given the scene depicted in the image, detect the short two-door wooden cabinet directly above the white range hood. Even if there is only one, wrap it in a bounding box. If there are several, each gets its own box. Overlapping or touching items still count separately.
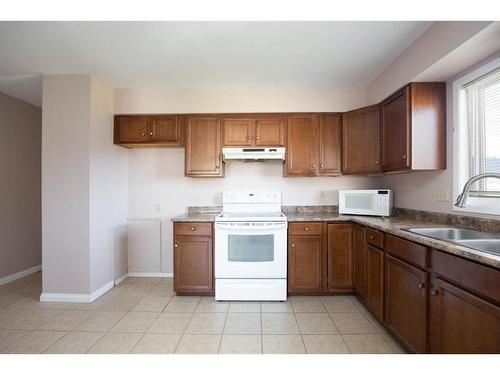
[222,114,285,147]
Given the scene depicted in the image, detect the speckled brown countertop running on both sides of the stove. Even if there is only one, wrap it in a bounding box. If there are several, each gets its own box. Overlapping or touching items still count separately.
[171,212,500,269]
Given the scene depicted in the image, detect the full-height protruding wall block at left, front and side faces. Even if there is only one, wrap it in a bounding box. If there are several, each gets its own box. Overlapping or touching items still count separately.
[42,75,128,299]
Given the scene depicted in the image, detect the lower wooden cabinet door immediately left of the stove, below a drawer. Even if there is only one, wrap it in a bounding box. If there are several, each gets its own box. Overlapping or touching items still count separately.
[174,236,213,293]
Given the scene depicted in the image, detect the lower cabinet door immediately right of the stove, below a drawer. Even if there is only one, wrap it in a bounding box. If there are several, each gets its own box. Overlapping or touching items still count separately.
[288,236,323,293]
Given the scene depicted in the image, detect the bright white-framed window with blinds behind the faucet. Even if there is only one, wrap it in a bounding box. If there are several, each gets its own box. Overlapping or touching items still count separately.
[453,58,500,215]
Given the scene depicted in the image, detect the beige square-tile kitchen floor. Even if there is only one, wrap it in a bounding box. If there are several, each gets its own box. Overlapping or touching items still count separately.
[0,273,404,354]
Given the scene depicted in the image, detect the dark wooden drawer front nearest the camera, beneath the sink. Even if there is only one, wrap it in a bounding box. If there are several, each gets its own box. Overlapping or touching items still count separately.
[431,249,500,303]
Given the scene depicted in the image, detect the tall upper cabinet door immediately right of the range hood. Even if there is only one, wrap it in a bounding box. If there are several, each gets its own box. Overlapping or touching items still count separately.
[285,114,319,176]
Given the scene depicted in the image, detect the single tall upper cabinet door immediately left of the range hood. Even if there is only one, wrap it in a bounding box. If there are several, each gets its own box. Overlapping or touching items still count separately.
[185,116,224,177]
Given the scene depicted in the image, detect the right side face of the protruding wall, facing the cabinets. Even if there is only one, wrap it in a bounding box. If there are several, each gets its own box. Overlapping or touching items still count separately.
[89,78,128,292]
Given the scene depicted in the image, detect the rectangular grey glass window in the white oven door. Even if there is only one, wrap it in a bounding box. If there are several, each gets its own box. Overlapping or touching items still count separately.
[227,234,274,262]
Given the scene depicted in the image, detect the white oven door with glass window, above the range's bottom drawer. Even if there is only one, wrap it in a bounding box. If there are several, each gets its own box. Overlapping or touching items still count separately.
[215,222,287,279]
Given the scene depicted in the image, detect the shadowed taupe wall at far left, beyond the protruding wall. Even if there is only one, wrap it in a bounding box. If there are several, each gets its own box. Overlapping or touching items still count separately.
[0,94,42,278]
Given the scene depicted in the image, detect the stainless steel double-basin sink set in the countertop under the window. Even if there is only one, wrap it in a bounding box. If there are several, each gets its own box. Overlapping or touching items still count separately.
[403,228,500,255]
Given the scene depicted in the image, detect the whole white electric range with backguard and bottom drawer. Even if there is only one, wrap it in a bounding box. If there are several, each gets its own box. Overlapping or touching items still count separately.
[214,191,287,301]
